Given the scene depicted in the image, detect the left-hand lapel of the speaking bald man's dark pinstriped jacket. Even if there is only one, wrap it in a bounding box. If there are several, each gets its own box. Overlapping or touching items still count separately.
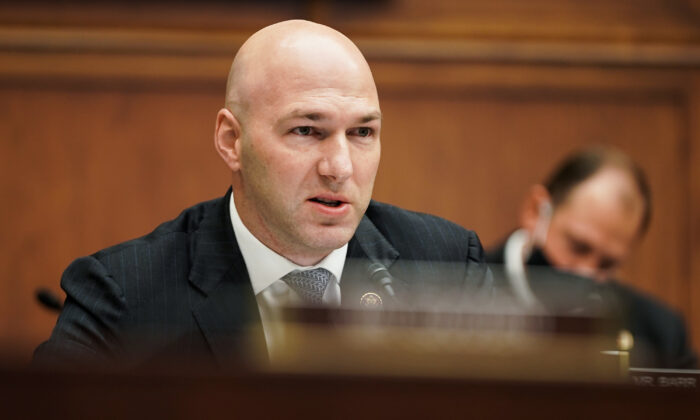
[189,190,265,366]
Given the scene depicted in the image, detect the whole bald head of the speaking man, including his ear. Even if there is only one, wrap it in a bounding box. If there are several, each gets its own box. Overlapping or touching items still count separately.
[214,20,381,265]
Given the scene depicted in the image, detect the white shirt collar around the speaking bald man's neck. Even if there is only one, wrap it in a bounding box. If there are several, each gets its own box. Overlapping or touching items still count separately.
[229,192,348,295]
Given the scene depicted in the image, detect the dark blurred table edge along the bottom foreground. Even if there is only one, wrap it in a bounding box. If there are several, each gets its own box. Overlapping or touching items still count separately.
[0,369,700,419]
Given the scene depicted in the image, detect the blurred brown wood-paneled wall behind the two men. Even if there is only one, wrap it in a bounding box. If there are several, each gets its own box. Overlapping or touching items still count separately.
[0,0,700,360]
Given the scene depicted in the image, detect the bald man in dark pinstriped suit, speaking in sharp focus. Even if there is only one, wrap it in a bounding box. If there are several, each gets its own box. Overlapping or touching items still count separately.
[35,20,491,367]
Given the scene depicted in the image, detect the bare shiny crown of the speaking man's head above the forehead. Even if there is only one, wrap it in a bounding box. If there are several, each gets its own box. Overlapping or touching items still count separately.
[226,20,378,122]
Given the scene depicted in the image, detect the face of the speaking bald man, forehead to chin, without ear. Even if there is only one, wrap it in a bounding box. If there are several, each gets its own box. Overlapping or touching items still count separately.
[234,69,381,265]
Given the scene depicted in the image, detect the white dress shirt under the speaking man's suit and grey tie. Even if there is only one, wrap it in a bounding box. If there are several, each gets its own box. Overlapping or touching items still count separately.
[229,193,348,357]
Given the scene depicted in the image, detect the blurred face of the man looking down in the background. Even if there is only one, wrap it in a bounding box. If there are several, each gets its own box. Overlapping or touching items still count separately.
[543,168,642,281]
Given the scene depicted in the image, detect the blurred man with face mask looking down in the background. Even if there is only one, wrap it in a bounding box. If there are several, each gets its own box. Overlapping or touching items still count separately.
[487,147,697,368]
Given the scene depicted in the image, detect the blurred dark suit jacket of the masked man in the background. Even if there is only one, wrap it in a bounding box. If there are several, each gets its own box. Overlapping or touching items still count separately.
[486,245,697,369]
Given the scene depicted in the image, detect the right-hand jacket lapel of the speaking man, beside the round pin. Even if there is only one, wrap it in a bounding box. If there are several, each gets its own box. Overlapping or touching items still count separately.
[340,216,404,308]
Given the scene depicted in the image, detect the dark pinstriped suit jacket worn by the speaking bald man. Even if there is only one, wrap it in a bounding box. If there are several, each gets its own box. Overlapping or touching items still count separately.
[35,191,491,367]
